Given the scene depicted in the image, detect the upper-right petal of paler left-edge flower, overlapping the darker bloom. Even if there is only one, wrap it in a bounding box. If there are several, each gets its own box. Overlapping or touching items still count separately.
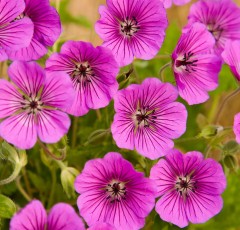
[41,72,74,111]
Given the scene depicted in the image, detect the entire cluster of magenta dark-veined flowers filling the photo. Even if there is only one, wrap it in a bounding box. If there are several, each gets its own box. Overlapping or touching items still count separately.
[0,0,240,230]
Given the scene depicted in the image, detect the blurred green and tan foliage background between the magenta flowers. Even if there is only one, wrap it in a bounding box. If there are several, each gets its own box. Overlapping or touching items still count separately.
[0,0,240,230]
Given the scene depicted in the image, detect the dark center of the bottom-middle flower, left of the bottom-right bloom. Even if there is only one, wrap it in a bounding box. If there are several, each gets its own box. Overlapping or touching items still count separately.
[106,181,127,203]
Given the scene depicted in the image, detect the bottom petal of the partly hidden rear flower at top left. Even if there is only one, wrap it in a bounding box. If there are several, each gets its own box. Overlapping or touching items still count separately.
[7,38,48,61]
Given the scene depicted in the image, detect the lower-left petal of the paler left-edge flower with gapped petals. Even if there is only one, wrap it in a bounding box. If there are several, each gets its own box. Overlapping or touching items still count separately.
[0,112,37,149]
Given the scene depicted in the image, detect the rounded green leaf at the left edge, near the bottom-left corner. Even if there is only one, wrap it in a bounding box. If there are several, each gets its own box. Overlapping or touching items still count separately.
[0,194,17,219]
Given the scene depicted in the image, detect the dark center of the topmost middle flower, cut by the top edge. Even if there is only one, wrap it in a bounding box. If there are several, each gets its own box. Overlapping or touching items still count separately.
[121,17,140,37]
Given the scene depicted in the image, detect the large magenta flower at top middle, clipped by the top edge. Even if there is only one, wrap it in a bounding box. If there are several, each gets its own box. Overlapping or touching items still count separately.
[95,0,168,66]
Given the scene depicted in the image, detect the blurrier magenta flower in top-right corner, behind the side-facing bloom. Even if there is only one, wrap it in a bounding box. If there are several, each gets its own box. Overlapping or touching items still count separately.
[188,0,240,55]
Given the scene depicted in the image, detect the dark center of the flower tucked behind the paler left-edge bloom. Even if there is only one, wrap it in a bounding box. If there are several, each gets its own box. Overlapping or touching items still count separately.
[70,63,95,86]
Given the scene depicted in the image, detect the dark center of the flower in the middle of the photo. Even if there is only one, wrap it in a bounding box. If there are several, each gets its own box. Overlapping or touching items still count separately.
[135,106,157,127]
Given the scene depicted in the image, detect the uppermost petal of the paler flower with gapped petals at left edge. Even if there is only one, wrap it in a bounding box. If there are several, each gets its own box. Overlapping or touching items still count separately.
[8,61,45,96]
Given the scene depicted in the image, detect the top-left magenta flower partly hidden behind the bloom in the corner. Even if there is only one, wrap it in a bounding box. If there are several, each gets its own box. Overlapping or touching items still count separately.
[7,0,61,61]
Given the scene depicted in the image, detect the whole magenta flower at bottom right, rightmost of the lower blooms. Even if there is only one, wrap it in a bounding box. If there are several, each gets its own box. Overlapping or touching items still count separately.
[150,150,226,228]
